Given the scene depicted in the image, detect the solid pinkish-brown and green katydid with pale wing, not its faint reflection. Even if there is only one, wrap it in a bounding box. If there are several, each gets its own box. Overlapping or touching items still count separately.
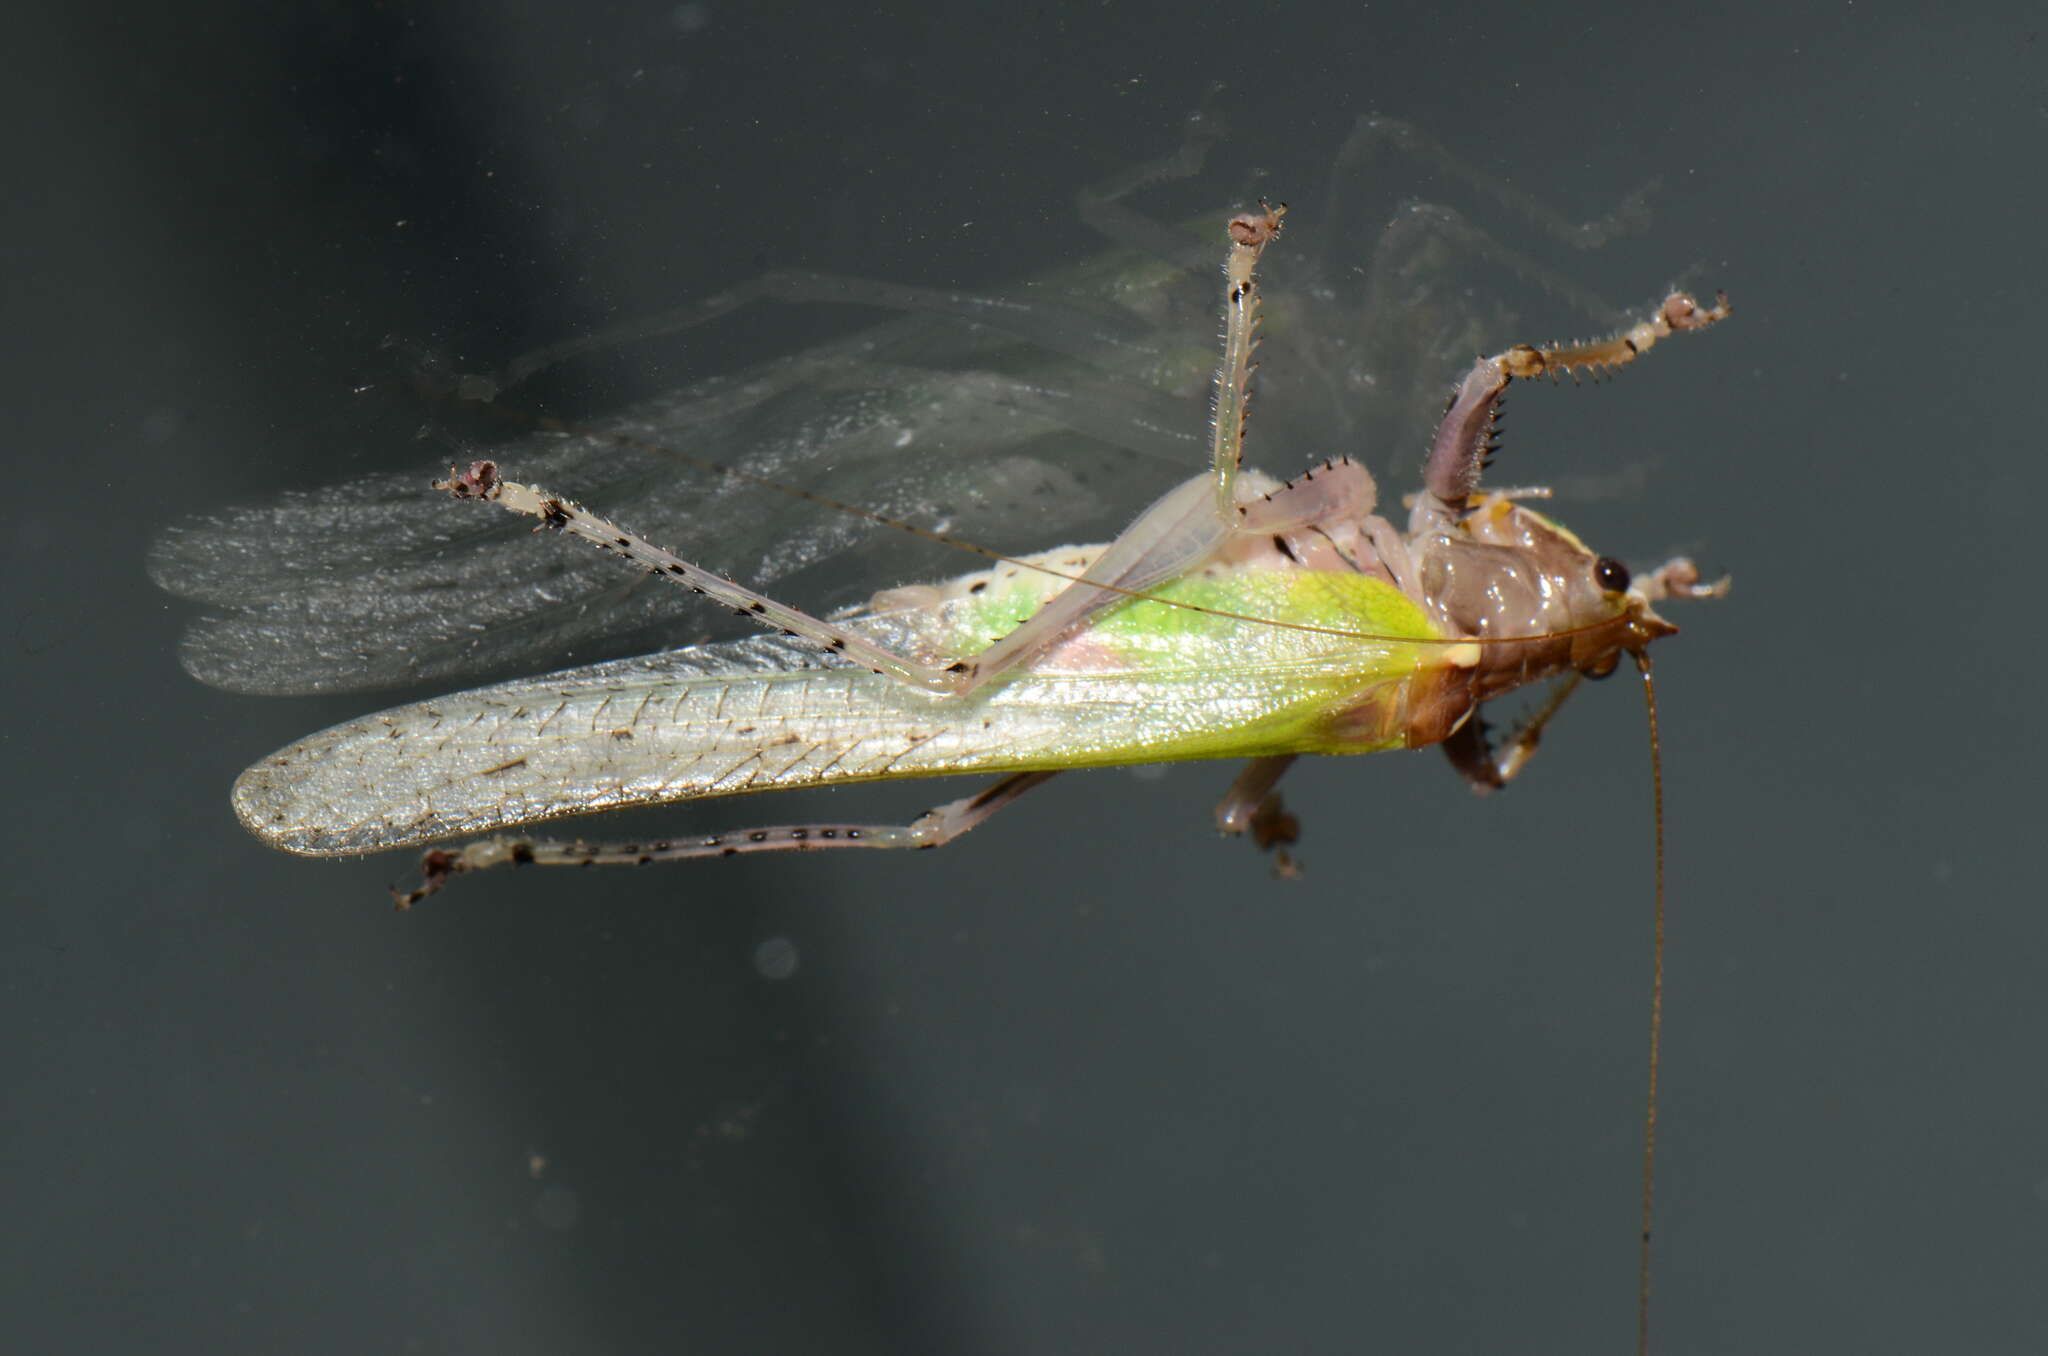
[220,207,1726,903]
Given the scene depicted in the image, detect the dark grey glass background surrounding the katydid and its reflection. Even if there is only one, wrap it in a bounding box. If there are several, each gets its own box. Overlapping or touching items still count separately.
[0,0,2048,1352]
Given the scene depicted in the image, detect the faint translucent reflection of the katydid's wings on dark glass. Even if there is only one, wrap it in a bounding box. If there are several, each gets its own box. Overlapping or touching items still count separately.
[150,260,1210,692]
